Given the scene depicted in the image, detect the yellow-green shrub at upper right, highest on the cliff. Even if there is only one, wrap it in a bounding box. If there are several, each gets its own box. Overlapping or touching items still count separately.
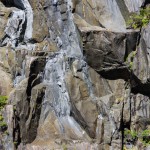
[128,7,150,29]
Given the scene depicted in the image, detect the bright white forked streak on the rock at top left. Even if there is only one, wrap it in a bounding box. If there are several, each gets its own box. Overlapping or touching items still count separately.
[3,0,33,48]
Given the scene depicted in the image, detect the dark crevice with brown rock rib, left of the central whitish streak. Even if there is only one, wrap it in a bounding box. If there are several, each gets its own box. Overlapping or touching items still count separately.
[14,57,46,144]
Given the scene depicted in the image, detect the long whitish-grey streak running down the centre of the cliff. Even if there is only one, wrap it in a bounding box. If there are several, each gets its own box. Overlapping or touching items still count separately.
[35,0,91,139]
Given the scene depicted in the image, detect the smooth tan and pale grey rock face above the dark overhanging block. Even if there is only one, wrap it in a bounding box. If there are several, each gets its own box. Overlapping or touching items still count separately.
[73,0,126,32]
